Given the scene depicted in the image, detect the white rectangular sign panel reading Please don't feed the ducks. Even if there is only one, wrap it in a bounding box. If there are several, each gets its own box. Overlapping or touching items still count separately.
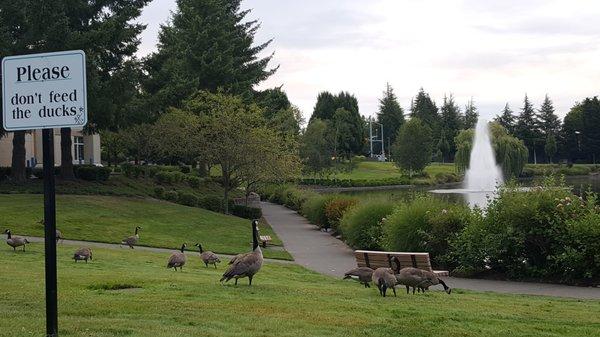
[2,50,87,131]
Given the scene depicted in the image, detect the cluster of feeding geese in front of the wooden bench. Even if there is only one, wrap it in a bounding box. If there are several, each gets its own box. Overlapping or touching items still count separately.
[344,256,452,297]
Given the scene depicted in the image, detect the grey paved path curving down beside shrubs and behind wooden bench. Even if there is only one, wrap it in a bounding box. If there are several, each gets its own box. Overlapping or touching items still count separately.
[261,202,600,299]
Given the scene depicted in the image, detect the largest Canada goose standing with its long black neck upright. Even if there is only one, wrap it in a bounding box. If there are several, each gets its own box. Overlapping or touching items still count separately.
[221,220,263,285]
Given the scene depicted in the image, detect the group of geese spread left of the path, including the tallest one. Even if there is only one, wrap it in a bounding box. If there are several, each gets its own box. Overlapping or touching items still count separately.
[4,220,264,285]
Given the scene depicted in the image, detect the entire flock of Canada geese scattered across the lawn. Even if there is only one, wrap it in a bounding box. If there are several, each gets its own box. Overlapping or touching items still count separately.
[4,220,452,297]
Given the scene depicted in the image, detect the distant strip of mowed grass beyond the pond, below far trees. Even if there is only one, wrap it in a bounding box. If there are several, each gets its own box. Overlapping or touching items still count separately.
[334,161,456,180]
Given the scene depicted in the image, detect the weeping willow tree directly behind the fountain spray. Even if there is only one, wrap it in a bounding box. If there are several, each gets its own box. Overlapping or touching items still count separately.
[454,123,528,178]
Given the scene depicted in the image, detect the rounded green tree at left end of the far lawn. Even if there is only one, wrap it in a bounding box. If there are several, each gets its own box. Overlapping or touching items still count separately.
[300,119,333,174]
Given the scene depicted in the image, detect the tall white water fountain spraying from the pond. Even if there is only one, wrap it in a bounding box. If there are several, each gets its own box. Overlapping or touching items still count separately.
[431,118,504,208]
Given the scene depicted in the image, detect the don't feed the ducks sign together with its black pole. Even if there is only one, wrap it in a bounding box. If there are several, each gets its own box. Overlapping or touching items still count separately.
[2,50,87,337]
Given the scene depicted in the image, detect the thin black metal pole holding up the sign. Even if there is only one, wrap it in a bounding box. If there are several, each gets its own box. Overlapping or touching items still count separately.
[42,129,58,337]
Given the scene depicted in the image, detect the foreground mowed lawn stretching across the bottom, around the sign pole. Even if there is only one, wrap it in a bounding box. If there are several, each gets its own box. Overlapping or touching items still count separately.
[0,244,600,337]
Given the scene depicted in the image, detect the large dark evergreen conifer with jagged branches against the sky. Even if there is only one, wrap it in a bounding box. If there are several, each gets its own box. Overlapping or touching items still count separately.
[144,0,277,111]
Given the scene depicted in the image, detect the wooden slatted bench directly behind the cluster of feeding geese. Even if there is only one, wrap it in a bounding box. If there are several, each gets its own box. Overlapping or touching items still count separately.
[354,250,450,276]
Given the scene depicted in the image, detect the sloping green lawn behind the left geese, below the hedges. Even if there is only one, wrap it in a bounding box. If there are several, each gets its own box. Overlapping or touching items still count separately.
[0,194,291,259]
